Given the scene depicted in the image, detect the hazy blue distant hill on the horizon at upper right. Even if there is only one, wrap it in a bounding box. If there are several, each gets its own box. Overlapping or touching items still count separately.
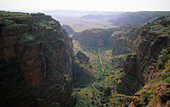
[109,11,170,26]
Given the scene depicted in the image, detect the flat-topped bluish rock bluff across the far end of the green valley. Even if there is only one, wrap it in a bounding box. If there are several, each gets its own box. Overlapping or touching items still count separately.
[75,25,134,47]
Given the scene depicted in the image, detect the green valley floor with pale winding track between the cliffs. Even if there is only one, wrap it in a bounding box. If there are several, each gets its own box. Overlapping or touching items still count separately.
[73,40,132,107]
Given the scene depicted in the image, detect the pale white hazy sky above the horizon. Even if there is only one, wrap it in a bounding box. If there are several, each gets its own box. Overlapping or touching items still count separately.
[0,0,170,11]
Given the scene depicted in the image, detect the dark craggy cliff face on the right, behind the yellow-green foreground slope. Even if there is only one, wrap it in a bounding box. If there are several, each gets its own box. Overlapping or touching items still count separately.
[117,17,170,94]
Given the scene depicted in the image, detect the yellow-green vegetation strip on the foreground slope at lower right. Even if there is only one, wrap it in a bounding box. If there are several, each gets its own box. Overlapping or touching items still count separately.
[139,58,170,107]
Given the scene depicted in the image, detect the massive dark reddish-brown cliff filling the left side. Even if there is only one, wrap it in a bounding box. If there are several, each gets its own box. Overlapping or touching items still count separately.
[0,12,74,107]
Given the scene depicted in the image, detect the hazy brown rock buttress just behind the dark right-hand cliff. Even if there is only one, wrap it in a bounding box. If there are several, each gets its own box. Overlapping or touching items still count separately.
[112,25,144,56]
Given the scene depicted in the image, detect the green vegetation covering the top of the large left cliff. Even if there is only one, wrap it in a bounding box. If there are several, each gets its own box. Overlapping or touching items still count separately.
[0,11,60,44]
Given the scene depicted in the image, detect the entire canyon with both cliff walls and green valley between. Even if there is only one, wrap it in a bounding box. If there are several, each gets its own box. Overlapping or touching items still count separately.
[0,11,170,107]
